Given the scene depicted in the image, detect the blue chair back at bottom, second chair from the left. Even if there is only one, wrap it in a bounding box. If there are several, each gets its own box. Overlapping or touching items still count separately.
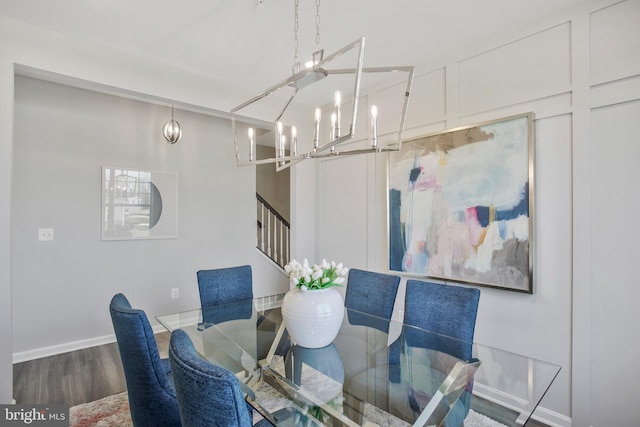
[169,329,252,427]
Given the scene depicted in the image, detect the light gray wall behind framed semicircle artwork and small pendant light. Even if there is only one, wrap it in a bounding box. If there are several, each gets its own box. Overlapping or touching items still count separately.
[11,76,288,359]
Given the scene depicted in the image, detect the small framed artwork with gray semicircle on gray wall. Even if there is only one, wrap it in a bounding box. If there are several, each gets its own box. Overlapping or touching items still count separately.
[102,166,178,240]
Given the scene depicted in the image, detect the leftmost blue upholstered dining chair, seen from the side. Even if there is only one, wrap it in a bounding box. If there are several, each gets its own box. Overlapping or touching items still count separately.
[109,294,181,427]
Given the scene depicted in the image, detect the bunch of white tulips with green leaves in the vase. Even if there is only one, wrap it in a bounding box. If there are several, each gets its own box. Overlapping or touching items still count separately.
[284,258,349,291]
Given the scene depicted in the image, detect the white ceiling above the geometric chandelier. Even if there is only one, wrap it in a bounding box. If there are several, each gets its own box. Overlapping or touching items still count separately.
[0,0,582,96]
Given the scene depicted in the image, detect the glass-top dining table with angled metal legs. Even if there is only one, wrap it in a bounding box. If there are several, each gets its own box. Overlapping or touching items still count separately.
[156,296,560,427]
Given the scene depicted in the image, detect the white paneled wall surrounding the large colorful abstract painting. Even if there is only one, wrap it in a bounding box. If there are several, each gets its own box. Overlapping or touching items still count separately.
[317,1,640,426]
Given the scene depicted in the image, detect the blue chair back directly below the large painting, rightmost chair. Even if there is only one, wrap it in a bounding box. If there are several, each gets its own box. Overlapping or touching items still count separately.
[404,280,480,360]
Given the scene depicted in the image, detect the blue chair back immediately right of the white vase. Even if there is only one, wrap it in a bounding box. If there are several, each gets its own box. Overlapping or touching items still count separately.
[344,268,400,319]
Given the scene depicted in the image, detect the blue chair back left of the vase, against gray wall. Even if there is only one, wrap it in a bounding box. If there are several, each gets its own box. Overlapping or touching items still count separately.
[196,265,253,309]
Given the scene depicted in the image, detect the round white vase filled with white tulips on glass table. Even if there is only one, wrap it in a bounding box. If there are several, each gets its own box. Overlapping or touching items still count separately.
[282,259,349,348]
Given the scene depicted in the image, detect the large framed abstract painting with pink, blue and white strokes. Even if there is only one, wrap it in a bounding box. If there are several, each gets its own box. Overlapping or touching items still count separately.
[388,113,534,293]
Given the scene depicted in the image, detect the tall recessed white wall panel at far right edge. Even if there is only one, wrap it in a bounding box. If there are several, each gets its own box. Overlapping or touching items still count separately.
[590,100,640,425]
